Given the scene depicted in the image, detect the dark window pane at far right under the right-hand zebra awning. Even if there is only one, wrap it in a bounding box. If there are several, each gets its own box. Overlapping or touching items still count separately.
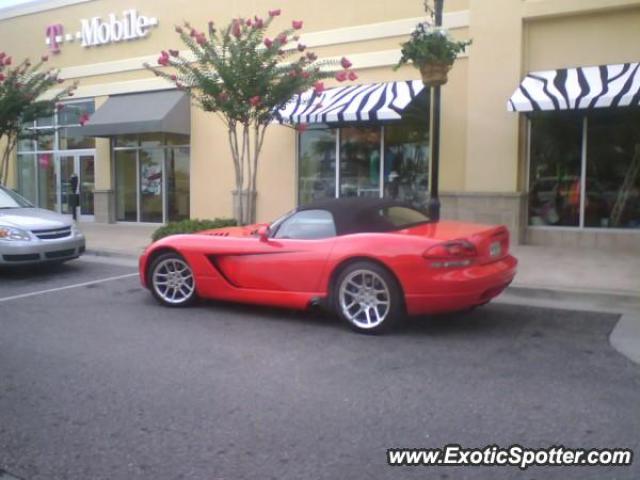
[584,109,640,228]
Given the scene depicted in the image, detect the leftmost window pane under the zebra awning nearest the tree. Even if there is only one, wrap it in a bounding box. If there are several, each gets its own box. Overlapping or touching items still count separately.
[298,128,336,205]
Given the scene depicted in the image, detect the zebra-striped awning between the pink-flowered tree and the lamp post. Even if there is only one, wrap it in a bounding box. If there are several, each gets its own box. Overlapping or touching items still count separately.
[276,80,424,124]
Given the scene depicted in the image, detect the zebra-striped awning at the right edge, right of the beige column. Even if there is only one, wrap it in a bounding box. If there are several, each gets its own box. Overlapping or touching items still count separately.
[507,63,640,112]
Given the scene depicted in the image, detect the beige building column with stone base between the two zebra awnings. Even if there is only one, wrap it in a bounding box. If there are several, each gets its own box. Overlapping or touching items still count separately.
[458,0,526,242]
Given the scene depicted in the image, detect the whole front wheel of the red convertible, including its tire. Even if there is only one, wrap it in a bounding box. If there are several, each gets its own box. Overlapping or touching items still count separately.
[148,253,196,307]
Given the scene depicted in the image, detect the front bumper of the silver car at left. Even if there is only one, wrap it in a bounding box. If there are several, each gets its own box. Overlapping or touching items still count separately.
[0,234,85,266]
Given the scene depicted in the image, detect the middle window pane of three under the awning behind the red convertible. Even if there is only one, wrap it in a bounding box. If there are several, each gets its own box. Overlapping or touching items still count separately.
[340,127,380,197]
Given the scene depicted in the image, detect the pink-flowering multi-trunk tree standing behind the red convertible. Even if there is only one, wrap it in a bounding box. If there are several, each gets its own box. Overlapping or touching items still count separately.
[146,10,356,224]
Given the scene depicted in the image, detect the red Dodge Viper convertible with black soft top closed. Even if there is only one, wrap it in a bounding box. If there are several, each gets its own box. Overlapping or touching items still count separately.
[140,198,517,333]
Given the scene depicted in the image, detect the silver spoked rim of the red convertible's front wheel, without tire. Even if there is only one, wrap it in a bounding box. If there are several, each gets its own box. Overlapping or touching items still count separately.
[151,258,195,305]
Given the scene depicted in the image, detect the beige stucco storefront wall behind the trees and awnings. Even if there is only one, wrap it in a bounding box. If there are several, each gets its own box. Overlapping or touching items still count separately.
[0,0,640,227]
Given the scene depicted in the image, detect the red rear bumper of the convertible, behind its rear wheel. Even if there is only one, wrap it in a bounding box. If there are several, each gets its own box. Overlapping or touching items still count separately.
[405,255,518,315]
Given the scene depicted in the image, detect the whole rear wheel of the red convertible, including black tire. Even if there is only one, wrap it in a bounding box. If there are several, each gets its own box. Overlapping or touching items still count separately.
[331,260,405,334]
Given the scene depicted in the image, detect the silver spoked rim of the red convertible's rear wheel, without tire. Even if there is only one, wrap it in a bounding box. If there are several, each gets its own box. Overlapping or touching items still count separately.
[339,270,391,329]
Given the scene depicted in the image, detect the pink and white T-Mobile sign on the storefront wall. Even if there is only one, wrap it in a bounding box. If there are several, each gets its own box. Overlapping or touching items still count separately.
[45,9,158,53]
